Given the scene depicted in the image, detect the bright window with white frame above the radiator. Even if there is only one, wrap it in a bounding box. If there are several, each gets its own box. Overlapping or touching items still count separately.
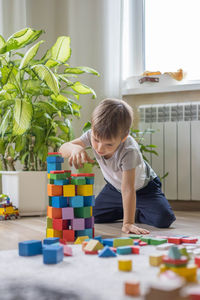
[122,0,200,80]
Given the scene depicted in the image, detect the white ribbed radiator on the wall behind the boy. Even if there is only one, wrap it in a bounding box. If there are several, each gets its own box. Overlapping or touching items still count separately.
[138,102,200,200]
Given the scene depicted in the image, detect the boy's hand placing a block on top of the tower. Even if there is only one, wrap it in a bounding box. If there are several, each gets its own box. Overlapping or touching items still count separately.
[68,148,94,169]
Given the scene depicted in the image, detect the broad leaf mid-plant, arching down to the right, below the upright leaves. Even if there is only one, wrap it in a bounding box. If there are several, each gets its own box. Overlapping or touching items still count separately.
[31,64,59,95]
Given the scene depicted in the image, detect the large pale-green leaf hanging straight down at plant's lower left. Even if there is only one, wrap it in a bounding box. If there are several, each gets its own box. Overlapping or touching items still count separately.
[13,99,33,135]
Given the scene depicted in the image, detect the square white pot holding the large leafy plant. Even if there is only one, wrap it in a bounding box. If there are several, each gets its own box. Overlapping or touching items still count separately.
[0,171,48,216]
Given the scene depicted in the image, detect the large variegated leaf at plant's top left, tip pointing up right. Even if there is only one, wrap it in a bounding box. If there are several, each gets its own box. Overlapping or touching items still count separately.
[6,28,43,51]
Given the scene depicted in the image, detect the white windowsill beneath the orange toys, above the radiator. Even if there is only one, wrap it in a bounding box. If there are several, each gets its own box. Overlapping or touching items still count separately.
[122,80,200,96]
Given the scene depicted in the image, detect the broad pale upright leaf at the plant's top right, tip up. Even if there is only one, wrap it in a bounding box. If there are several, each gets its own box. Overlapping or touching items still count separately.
[51,36,71,63]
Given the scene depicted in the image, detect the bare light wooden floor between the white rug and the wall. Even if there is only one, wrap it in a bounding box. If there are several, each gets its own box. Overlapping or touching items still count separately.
[0,211,200,250]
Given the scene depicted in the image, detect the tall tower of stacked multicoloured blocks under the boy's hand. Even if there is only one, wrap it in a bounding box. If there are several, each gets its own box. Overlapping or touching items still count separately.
[46,152,95,242]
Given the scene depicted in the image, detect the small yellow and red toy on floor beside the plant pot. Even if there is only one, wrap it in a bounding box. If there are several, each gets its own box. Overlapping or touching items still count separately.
[0,194,19,221]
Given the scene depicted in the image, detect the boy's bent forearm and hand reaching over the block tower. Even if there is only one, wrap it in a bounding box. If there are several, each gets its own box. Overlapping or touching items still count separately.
[59,138,94,169]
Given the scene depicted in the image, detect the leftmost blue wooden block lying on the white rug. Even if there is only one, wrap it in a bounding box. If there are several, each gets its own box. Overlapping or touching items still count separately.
[18,240,42,256]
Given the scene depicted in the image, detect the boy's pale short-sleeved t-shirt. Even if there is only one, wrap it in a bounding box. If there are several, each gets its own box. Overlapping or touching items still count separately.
[80,130,157,191]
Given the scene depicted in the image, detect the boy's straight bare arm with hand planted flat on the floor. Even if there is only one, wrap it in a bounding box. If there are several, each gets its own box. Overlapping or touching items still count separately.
[122,169,149,234]
